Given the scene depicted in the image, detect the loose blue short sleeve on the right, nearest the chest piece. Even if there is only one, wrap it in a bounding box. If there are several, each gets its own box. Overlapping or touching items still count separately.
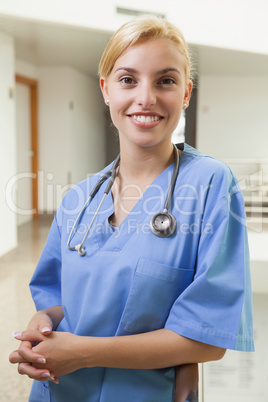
[165,168,254,351]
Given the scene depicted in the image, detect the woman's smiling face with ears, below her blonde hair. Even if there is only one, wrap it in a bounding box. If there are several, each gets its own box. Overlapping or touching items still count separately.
[100,39,192,152]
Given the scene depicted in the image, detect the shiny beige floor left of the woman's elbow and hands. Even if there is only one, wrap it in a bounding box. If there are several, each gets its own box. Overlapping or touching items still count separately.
[0,216,52,402]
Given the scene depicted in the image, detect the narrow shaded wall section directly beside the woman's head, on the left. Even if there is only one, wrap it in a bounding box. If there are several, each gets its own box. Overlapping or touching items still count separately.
[69,69,106,183]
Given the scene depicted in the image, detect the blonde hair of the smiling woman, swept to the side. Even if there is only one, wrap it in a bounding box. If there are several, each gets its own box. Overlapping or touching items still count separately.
[99,14,192,83]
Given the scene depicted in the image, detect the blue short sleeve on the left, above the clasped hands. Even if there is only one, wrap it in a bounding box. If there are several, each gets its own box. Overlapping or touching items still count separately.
[30,210,61,310]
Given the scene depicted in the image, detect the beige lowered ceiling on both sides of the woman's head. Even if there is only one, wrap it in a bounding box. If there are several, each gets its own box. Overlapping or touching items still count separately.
[0,15,268,79]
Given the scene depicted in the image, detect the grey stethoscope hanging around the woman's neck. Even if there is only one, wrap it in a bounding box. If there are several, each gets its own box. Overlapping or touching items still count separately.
[67,145,179,256]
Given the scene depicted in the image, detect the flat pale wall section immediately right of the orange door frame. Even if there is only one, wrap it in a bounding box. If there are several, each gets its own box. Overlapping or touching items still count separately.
[39,67,71,212]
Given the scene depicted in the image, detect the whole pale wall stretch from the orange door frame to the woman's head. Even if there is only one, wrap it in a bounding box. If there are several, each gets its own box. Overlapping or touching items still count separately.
[39,67,105,212]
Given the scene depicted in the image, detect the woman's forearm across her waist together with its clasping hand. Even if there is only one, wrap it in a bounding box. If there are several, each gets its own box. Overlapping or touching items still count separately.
[10,329,225,378]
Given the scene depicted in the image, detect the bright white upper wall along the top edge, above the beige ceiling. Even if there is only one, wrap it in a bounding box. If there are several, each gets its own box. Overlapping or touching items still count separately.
[0,0,268,54]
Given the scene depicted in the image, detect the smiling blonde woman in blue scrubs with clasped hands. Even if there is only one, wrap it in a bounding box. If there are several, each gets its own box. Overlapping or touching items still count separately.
[10,12,254,402]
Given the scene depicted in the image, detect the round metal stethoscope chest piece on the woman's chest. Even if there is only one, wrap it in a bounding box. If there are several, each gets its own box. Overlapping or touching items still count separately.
[150,211,177,237]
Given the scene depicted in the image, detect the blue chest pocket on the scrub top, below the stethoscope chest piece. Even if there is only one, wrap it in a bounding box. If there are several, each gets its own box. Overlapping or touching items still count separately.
[120,258,194,335]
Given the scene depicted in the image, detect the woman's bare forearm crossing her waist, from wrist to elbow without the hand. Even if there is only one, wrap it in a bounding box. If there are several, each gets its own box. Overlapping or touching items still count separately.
[77,329,225,369]
